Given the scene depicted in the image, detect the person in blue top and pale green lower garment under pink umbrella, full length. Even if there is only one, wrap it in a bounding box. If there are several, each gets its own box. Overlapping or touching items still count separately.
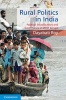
[30,42,45,83]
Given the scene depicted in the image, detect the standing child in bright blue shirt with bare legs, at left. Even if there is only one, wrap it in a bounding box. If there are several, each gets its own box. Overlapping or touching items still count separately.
[4,36,13,82]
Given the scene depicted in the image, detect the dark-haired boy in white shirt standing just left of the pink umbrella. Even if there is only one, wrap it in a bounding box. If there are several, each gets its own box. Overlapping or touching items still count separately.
[21,36,31,81]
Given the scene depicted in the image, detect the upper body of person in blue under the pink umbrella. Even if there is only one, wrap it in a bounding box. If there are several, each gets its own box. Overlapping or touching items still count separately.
[30,42,45,67]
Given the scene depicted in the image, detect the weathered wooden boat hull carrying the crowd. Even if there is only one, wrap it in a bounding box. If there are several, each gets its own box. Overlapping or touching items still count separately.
[0,82,47,96]
